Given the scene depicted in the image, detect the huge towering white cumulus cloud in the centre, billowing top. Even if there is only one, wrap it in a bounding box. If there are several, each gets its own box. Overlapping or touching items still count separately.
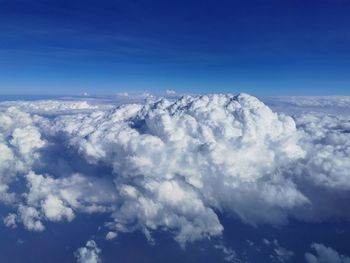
[60,95,307,243]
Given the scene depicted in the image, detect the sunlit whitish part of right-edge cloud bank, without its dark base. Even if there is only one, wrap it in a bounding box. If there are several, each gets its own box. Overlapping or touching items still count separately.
[297,114,350,190]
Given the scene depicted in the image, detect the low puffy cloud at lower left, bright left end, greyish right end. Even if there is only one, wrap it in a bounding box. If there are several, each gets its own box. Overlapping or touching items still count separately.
[21,172,116,227]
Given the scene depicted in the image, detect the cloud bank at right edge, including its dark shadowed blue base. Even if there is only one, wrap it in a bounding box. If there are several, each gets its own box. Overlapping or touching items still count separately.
[291,113,350,221]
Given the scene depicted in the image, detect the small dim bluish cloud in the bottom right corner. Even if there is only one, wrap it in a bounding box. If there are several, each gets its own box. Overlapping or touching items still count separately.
[305,243,350,263]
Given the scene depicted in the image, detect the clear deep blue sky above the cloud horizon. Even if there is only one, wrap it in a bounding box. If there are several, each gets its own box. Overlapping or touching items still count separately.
[0,0,350,95]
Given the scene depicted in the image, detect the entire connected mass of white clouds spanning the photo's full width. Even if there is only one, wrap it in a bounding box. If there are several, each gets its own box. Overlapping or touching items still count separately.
[0,94,350,246]
